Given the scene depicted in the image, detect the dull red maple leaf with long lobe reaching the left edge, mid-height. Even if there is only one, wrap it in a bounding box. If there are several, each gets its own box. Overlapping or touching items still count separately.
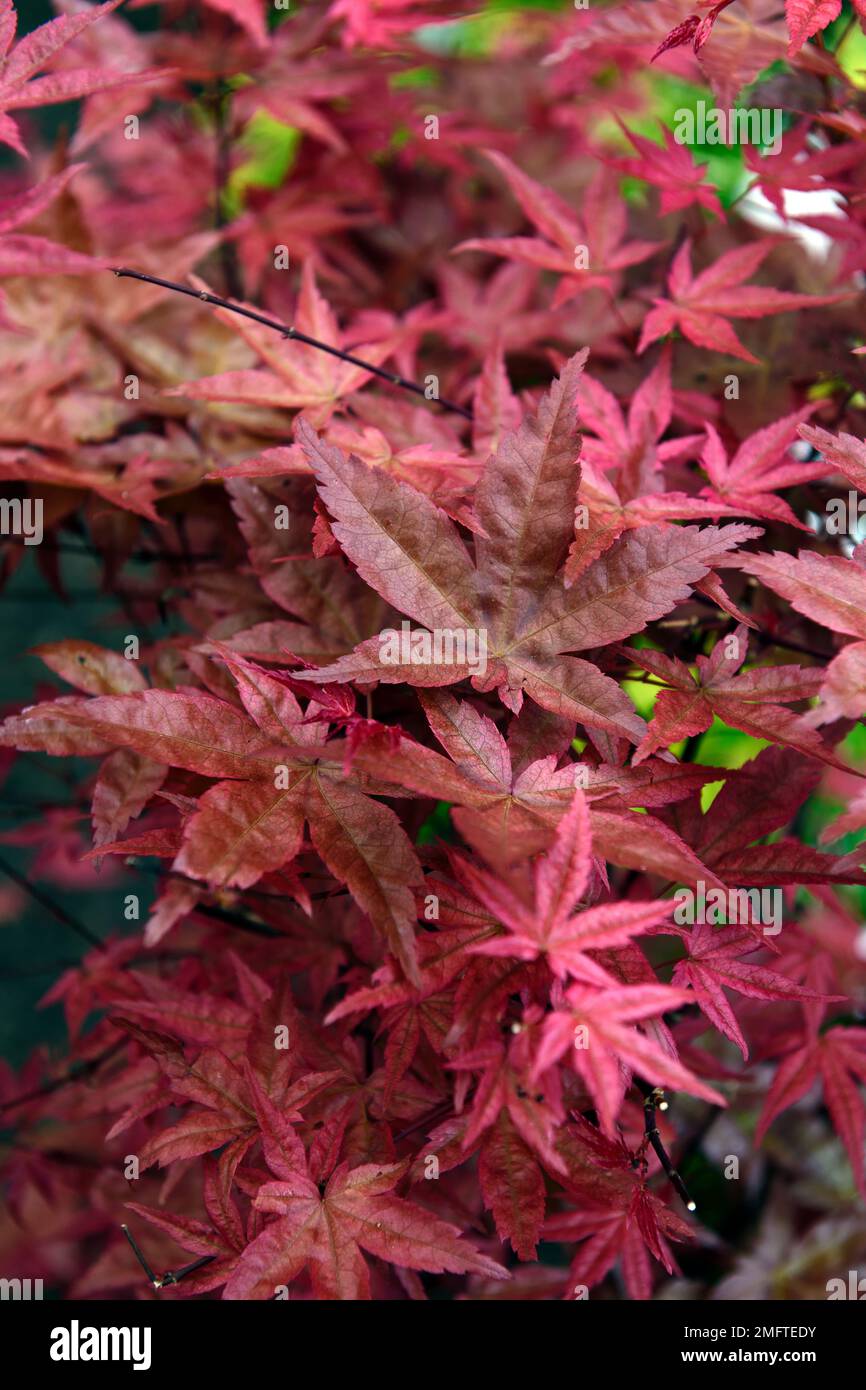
[0,657,421,979]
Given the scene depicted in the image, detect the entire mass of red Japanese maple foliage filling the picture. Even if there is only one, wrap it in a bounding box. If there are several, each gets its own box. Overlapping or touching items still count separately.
[0,0,866,1300]
